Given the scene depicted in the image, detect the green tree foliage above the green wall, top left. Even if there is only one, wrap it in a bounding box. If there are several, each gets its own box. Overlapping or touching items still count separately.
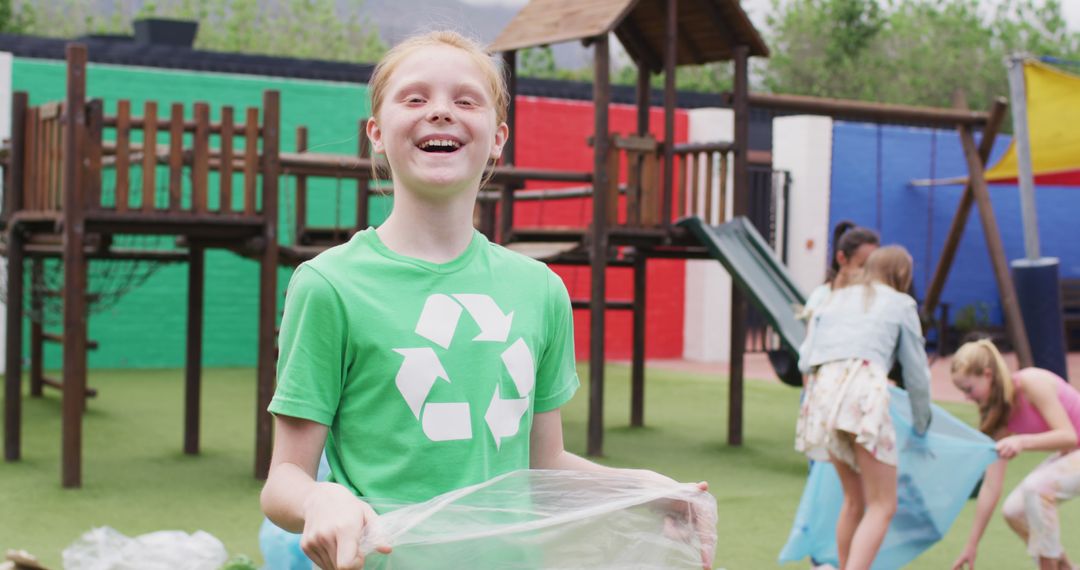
[12,0,387,62]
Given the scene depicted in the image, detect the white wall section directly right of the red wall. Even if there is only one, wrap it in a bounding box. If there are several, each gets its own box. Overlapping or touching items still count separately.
[683,109,734,362]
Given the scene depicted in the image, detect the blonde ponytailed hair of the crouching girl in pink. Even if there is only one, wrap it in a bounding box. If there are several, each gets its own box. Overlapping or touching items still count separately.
[950,339,1016,436]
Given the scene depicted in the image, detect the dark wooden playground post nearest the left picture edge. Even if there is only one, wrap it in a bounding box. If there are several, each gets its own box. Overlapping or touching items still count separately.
[3,92,29,461]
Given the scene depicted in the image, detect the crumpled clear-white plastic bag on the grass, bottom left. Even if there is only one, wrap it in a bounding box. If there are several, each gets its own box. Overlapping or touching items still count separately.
[62,527,229,570]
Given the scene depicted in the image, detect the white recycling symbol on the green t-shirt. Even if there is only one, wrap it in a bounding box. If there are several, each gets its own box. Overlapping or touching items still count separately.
[394,294,536,448]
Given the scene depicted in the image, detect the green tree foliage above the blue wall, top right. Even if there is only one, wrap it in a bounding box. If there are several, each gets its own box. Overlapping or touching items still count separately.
[761,0,1080,108]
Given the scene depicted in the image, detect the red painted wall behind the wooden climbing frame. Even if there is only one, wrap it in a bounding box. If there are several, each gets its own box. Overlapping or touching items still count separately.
[514,97,689,358]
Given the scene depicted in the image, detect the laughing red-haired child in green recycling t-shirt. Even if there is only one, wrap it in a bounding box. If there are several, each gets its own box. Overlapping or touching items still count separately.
[254,31,712,570]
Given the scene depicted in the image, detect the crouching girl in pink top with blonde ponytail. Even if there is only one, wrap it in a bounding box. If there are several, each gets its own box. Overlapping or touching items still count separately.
[951,340,1080,570]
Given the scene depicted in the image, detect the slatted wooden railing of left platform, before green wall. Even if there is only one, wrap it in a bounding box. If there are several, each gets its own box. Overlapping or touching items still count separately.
[13,92,276,216]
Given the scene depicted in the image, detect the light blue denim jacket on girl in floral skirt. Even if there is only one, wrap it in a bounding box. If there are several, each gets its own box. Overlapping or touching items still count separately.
[799,283,930,433]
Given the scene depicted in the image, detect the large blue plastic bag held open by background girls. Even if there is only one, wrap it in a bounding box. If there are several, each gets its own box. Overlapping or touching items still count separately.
[780,388,998,570]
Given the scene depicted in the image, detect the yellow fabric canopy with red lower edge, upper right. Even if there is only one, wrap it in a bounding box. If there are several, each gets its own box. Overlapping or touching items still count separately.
[986,59,1080,186]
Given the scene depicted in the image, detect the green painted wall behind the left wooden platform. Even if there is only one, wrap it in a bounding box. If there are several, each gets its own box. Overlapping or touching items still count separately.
[12,58,386,368]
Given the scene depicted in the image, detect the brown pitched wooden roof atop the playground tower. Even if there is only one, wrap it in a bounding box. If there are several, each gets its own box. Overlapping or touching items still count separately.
[490,0,769,71]
